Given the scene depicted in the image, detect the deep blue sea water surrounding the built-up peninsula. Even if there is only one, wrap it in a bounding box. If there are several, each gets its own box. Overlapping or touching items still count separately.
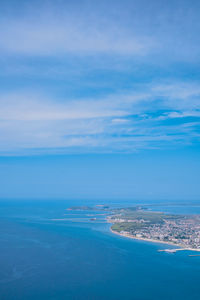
[0,200,200,300]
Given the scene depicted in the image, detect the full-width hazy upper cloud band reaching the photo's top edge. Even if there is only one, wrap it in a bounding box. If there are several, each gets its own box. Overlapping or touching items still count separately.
[0,0,200,62]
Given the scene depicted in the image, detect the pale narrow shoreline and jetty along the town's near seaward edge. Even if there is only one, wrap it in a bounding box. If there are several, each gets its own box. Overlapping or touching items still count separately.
[110,227,200,252]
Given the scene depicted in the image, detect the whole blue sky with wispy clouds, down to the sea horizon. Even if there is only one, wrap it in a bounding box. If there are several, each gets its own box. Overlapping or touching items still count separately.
[0,0,200,201]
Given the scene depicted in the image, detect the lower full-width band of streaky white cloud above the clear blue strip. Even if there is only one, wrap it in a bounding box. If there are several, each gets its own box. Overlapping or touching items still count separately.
[0,79,200,153]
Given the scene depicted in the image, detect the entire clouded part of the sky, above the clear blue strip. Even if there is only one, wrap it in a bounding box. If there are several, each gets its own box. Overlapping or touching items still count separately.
[0,0,200,154]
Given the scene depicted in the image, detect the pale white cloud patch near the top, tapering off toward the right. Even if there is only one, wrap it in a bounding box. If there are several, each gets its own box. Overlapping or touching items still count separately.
[0,15,154,56]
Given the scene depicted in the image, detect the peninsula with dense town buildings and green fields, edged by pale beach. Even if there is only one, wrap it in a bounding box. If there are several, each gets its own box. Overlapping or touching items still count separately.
[107,207,200,251]
